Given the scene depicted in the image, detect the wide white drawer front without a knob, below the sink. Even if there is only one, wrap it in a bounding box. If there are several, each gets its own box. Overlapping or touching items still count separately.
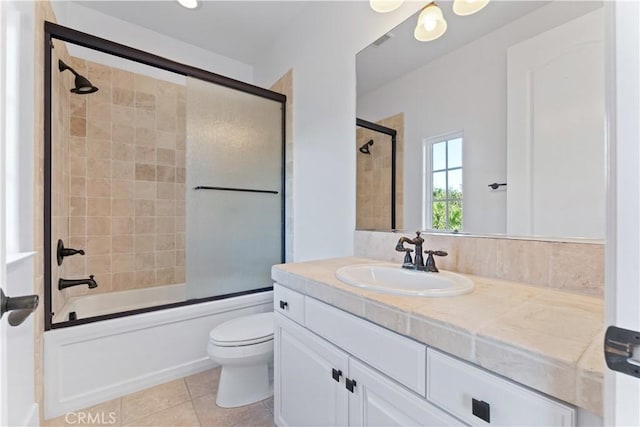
[304,297,426,396]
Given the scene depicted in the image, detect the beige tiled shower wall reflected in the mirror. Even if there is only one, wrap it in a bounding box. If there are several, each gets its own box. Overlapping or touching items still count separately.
[356,113,404,230]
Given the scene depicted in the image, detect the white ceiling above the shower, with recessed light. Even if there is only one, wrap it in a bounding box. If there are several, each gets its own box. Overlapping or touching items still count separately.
[73,0,308,64]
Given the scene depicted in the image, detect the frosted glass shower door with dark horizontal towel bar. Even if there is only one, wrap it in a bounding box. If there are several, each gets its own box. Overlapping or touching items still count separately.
[185,78,284,299]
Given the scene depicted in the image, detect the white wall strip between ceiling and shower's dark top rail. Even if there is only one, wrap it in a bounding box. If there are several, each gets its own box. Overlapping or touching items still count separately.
[52,1,253,83]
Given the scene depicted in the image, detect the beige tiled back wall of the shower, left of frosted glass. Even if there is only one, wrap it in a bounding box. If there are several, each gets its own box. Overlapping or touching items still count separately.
[54,58,186,296]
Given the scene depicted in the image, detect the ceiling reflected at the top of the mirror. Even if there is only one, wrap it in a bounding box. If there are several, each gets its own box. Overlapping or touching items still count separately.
[356,0,549,96]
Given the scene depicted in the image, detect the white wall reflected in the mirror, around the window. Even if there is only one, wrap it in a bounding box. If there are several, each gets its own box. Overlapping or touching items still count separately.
[357,2,602,233]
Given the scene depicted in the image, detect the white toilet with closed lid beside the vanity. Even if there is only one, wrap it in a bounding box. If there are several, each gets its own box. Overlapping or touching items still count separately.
[207,312,274,408]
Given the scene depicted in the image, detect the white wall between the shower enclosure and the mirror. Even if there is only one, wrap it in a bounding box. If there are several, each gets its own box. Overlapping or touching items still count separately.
[254,1,422,261]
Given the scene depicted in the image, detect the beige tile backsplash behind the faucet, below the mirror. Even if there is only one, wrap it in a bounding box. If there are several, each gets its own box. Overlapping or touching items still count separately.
[354,231,604,297]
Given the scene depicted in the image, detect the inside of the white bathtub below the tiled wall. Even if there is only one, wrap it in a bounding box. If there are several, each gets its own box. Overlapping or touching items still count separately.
[53,283,186,323]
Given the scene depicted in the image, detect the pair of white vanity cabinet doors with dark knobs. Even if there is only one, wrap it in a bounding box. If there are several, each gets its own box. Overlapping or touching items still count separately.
[274,313,461,427]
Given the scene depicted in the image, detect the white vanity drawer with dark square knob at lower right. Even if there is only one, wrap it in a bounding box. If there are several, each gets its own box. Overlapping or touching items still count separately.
[427,348,575,426]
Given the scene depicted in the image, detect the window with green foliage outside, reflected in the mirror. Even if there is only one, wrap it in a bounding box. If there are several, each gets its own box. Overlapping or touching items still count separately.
[423,132,463,231]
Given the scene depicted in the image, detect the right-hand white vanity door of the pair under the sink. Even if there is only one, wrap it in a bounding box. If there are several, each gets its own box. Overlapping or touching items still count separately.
[348,359,463,426]
